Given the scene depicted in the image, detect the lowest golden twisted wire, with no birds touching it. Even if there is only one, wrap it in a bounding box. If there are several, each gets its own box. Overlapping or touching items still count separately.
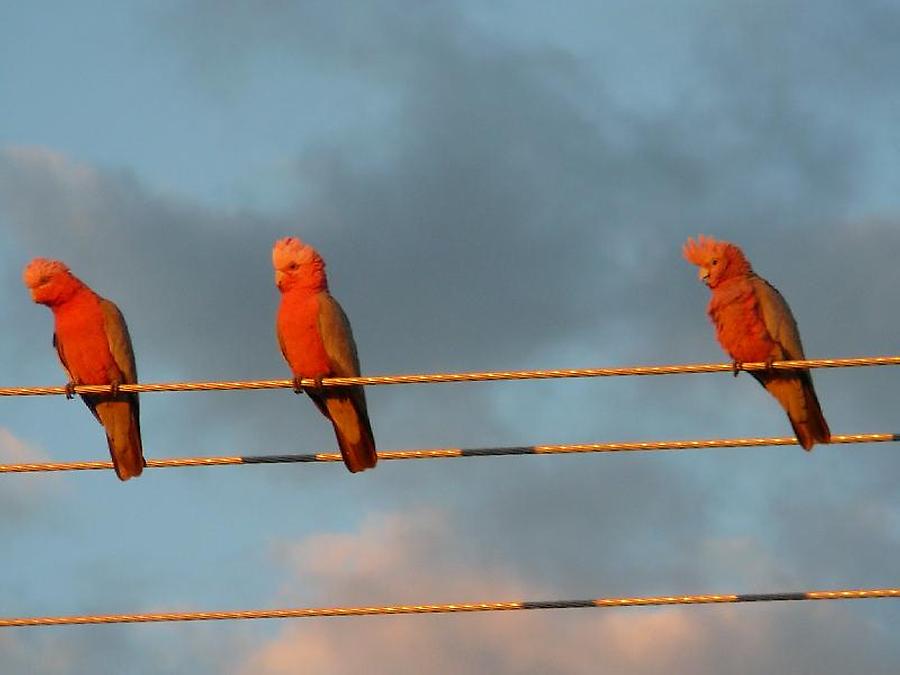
[0,588,900,628]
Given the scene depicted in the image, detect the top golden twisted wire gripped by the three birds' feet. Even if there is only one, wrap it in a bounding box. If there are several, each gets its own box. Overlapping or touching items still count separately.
[0,356,900,396]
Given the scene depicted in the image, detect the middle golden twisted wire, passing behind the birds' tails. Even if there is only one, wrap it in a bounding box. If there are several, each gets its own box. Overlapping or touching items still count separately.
[0,434,900,473]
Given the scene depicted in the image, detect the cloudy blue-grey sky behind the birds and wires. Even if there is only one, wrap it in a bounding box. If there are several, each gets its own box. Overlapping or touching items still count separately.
[0,0,900,675]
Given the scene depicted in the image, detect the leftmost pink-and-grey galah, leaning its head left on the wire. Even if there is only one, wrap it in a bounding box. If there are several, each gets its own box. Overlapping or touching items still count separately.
[22,258,144,481]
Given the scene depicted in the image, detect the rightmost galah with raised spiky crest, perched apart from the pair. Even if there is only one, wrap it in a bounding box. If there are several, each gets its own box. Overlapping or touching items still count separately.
[682,235,831,450]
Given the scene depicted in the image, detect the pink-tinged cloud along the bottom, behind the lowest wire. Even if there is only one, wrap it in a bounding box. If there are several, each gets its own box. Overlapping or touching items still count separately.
[234,511,896,675]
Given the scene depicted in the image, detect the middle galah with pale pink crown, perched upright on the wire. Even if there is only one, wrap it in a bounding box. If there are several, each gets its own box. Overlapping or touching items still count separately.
[272,237,378,473]
